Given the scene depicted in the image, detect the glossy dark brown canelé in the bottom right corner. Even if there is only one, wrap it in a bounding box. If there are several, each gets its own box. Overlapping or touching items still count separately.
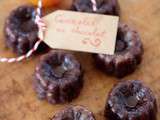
[105,80,157,120]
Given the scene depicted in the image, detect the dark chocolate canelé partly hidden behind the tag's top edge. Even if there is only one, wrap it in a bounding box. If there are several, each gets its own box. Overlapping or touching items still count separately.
[71,0,120,16]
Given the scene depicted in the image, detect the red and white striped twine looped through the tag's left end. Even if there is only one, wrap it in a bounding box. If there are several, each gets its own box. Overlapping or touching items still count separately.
[0,0,46,63]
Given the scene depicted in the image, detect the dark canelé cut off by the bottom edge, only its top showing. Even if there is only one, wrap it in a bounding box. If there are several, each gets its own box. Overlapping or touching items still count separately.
[51,106,95,120]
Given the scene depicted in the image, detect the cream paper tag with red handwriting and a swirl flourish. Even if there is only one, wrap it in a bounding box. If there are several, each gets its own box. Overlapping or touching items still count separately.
[43,10,119,54]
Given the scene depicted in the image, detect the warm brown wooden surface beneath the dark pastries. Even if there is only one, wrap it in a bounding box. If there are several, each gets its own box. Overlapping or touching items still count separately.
[0,0,160,120]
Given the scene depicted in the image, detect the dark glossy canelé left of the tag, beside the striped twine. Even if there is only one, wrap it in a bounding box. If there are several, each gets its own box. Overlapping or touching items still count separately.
[4,5,47,55]
